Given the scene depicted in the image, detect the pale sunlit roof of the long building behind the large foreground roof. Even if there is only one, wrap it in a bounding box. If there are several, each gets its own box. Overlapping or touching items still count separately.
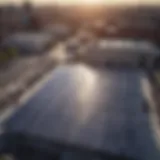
[90,39,160,55]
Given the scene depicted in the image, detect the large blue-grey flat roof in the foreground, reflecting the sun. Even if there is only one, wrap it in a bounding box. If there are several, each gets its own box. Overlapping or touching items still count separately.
[5,64,160,160]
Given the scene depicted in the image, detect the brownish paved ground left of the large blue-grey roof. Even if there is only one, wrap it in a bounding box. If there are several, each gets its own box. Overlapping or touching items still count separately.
[0,44,65,111]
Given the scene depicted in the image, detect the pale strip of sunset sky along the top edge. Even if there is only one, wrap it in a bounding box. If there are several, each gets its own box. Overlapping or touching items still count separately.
[0,0,160,5]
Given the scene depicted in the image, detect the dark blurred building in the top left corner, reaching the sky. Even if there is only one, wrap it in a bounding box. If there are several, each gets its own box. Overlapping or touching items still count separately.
[0,1,33,43]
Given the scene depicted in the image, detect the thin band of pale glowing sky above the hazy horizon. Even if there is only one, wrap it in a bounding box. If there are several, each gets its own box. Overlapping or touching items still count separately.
[0,0,160,6]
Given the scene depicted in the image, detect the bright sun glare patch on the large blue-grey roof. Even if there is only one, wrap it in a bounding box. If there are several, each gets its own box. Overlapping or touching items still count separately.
[72,65,97,123]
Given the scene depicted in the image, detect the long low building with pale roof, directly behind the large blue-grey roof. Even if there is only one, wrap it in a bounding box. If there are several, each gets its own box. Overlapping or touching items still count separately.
[83,40,160,67]
